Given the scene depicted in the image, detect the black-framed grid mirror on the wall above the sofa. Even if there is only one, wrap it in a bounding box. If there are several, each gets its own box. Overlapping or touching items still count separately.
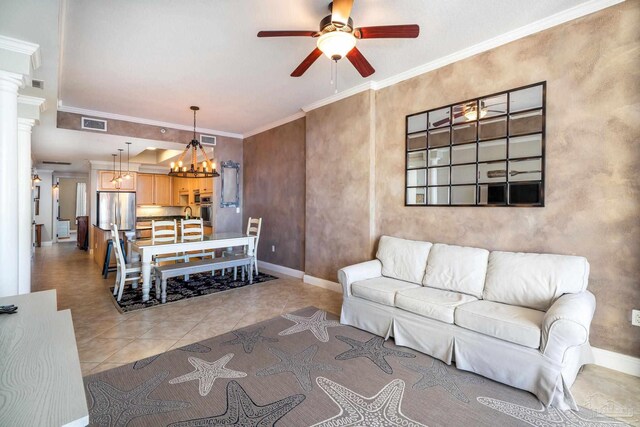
[405,82,546,207]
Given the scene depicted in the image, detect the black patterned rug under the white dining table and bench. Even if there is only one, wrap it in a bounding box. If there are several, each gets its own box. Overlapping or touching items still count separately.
[109,272,277,313]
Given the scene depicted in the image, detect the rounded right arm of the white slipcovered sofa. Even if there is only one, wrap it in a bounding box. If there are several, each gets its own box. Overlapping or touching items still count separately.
[540,291,596,363]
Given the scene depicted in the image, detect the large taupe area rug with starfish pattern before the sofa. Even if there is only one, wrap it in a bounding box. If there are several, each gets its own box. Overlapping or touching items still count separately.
[84,307,625,427]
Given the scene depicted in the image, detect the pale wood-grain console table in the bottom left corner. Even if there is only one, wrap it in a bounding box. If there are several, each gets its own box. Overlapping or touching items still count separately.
[0,290,89,427]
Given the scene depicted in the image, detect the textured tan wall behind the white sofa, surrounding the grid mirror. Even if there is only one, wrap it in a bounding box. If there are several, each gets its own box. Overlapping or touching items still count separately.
[376,1,640,356]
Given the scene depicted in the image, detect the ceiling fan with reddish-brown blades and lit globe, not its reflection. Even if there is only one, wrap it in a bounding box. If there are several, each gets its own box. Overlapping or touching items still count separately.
[258,0,420,77]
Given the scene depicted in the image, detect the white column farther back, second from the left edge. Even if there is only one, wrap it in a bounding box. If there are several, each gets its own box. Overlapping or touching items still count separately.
[17,118,36,294]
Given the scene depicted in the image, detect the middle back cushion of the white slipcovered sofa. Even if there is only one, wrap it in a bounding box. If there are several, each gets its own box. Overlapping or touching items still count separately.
[422,243,489,298]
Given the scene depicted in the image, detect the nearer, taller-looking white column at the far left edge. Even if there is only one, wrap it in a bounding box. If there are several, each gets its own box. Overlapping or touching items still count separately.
[0,70,22,296]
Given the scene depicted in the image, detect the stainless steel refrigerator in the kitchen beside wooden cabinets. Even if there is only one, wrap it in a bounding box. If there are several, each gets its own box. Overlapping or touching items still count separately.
[96,191,136,231]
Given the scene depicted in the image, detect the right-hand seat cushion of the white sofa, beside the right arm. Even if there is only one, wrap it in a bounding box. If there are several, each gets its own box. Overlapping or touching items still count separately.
[455,301,544,348]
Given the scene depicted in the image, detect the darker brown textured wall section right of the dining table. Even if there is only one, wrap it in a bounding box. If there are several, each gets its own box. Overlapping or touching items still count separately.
[243,117,305,271]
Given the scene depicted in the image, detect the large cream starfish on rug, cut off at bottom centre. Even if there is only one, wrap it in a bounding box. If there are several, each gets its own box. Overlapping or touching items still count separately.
[312,377,426,427]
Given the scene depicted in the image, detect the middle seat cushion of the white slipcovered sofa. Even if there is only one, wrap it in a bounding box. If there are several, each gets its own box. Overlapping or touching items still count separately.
[396,287,477,323]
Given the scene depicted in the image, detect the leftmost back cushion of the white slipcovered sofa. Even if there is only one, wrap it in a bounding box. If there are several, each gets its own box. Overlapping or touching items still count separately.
[376,236,432,284]
